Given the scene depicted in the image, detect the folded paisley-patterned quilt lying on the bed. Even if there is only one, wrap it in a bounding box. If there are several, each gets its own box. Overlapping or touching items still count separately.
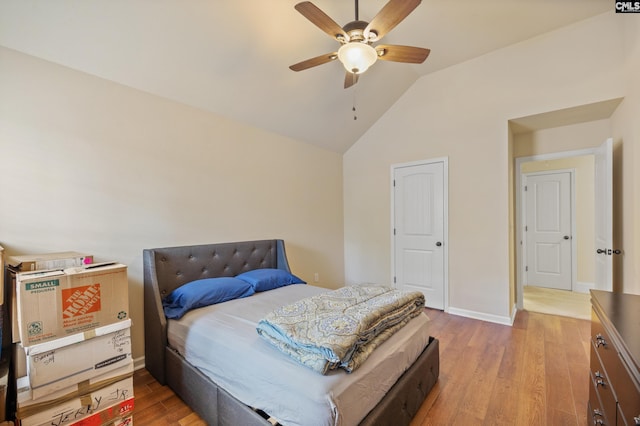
[257,286,424,374]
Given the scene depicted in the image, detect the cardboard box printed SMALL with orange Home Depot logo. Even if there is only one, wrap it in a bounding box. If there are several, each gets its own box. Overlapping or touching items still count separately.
[16,263,129,348]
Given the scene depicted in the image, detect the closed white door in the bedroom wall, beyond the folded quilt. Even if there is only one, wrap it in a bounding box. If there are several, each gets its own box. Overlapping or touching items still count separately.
[393,161,446,309]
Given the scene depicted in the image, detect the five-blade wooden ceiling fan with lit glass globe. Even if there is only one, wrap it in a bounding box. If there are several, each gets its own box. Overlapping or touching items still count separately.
[289,0,430,89]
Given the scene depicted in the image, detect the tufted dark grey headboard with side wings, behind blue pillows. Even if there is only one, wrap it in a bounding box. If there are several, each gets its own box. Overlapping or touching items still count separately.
[143,239,291,384]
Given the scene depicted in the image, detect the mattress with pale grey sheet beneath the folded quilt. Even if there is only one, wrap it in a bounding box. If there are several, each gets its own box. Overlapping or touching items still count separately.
[168,285,429,426]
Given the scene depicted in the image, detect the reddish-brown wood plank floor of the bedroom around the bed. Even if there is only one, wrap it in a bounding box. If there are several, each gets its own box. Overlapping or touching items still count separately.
[134,310,590,426]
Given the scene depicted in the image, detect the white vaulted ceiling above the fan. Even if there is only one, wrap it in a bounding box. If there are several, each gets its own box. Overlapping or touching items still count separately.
[0,0,613,153]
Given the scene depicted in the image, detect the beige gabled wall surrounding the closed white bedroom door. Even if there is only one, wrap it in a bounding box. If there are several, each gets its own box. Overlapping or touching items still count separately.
[344,13,640,320]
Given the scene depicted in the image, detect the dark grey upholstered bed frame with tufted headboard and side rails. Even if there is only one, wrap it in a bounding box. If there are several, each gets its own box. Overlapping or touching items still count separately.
[143,240,440,426]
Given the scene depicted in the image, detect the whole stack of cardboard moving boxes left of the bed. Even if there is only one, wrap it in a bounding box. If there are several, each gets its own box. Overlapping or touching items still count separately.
[8,252,133,426]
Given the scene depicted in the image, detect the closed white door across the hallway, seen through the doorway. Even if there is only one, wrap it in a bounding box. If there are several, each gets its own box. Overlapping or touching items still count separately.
[525,172,572,290]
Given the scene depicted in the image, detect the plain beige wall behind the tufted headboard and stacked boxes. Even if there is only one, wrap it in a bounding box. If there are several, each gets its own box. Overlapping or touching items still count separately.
[0,48,344,358]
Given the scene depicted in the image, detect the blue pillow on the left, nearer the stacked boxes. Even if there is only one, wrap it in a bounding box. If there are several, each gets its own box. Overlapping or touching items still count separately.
[162,277,255,319]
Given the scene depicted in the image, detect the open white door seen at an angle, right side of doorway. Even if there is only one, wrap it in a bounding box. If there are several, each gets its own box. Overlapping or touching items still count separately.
[594,139,613,291]
